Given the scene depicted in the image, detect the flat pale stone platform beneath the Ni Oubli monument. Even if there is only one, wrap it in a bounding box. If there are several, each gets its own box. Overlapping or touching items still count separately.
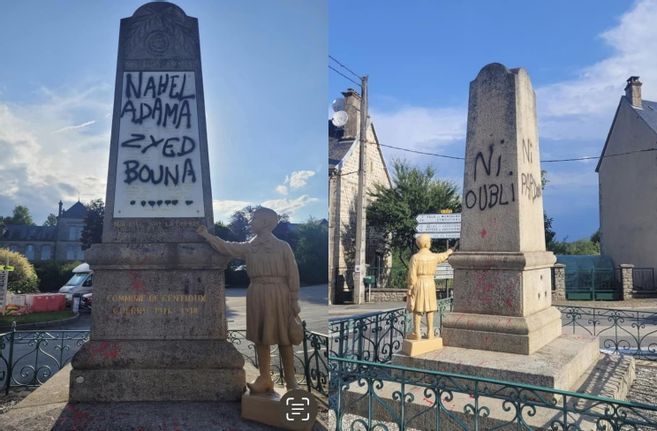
[392,335,600,390]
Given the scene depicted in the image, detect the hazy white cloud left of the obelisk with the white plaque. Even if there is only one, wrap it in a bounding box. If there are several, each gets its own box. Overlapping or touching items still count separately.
[0,85,112,223]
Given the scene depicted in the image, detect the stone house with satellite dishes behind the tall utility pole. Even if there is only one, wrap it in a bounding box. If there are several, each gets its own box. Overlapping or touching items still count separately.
[328,89,391,303]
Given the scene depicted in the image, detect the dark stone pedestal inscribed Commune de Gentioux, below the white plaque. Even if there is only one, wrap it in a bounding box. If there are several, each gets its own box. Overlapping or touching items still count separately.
[70,243,245,402]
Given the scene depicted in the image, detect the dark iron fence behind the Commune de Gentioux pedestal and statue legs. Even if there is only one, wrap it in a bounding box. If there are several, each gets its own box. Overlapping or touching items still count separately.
[0,322,328,396]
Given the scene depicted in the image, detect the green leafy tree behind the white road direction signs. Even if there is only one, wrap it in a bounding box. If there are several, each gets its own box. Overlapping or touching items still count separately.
[367,160,461,267]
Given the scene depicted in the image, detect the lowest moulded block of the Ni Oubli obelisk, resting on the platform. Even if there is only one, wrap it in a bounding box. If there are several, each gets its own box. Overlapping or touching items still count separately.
[440,307,562,355]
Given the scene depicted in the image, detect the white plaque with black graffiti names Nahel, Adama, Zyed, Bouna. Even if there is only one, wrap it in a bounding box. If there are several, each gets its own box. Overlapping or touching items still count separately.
[114,71,204,218]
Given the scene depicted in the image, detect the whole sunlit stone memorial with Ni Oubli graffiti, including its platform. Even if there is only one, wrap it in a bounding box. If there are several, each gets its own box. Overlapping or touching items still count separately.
[394,63,632,390]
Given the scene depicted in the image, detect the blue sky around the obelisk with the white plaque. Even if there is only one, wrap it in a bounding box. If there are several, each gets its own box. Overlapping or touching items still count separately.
[0,0,328,224]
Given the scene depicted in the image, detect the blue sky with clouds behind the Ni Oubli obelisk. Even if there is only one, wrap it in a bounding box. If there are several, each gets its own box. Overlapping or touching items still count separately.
[328,0,657,240]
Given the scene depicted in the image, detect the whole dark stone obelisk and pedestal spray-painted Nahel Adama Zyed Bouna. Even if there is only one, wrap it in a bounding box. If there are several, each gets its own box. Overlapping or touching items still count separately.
[70,2,245,402]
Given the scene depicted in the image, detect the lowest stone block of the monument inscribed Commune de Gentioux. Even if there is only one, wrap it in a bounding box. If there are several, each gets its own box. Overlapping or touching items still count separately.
[70,340,245,402]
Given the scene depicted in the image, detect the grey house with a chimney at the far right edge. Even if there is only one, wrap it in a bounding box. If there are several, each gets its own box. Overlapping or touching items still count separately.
[595,76,657,286]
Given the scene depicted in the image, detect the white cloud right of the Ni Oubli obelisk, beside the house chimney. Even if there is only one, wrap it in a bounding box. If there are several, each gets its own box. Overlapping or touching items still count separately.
[529,0,657,139]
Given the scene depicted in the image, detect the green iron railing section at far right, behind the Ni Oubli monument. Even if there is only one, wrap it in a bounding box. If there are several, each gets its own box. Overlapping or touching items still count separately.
[557,305,657,360]
